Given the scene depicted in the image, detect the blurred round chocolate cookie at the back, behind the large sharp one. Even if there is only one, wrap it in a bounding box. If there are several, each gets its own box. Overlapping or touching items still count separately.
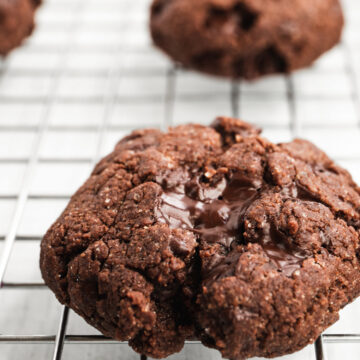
[151,0,343,79]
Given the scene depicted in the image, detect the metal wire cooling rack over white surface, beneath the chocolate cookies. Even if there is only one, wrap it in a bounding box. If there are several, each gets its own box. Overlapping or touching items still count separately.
[0,0,360,360]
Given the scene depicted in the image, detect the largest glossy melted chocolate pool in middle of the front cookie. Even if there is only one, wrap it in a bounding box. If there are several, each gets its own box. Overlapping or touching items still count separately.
[157,177,258,247]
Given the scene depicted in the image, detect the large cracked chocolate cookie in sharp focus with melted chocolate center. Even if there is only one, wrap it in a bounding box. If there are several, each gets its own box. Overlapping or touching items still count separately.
[40,118,360,359]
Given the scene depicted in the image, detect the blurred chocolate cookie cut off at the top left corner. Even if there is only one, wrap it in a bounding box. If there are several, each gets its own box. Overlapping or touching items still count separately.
[0,0,40,55]
